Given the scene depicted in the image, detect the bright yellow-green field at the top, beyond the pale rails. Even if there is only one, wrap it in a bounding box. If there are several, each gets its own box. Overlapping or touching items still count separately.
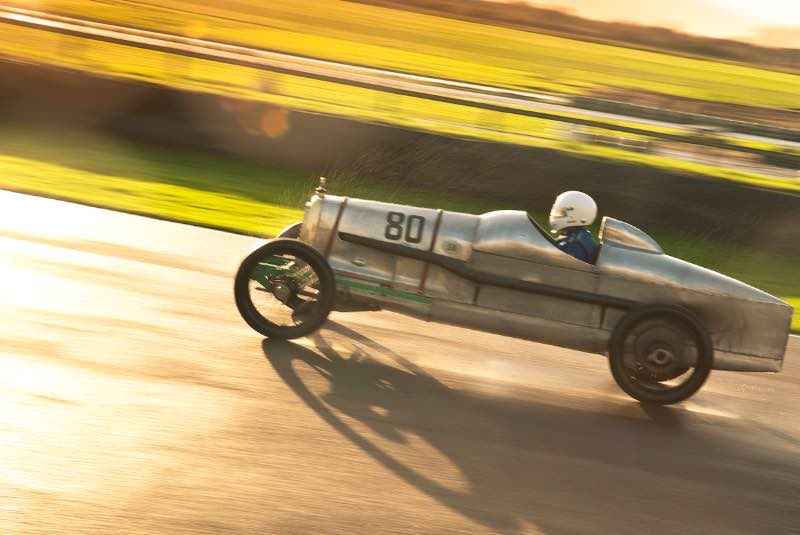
[10,0,800,109]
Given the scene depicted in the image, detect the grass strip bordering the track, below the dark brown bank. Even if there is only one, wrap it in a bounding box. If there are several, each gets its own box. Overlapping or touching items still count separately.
[0,125,800,331]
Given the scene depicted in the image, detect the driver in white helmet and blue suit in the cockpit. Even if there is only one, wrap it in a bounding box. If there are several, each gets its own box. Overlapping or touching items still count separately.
[550,191,598,264]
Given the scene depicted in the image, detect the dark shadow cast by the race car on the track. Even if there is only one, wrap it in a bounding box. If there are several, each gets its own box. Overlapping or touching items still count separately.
[263,322,800,533]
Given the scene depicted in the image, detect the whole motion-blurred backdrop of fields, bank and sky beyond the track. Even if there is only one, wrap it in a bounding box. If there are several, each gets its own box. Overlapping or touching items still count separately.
[0,0,800,322]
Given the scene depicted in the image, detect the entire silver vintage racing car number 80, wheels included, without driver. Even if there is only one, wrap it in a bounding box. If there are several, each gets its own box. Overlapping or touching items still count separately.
[235,180,792,404]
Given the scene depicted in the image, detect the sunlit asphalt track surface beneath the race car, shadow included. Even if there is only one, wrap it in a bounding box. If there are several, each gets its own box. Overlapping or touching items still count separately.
[0,192,800,534]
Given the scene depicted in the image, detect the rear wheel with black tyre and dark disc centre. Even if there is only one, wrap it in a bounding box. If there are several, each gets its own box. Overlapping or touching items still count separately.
[608,306,714,405]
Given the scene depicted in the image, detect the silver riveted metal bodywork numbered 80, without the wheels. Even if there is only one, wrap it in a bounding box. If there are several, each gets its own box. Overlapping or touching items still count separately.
[300,192,792,372]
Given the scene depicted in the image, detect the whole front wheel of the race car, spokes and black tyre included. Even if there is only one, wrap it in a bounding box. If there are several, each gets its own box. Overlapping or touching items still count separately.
[234,238,336,339]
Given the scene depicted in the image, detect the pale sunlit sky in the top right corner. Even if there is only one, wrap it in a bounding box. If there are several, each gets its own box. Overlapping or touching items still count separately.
[512,0,800,47]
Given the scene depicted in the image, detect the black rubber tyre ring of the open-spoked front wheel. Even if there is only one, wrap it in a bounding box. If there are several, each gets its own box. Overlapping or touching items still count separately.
[234,238,336,340]
